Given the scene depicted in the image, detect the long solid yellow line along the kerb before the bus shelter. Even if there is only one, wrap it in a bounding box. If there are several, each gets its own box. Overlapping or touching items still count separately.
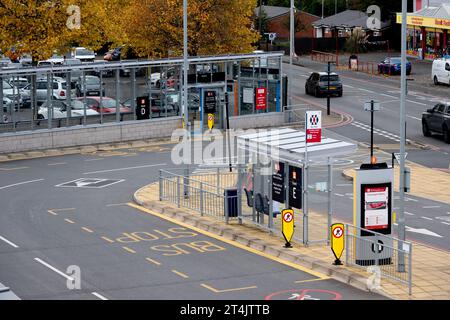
[128,202,330,279]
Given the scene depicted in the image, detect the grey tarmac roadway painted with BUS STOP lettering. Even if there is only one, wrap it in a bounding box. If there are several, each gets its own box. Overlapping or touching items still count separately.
[0,150,384,300]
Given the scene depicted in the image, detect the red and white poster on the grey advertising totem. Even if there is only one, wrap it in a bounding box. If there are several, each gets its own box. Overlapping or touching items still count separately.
[364,187,389,230]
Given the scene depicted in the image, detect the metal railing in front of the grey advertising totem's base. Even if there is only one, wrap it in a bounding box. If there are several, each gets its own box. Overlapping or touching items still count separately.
[345,224,412,295]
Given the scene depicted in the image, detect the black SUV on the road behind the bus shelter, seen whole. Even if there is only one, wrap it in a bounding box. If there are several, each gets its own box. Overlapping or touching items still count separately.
[305,72,343,97]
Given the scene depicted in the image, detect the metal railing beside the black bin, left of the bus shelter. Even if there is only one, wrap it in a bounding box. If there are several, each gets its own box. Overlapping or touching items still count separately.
[159,168,240,223]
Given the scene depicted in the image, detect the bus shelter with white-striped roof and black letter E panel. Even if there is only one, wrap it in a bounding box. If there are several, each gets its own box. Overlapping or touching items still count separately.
[237,128,357,245]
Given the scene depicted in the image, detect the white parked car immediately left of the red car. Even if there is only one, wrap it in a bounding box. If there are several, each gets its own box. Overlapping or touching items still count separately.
[38,99,98,119]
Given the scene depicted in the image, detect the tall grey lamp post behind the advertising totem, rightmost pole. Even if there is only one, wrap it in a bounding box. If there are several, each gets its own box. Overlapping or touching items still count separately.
[398,0,407,271]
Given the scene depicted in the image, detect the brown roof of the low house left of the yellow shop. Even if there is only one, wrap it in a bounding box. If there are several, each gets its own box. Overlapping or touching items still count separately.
[312,10,390,29]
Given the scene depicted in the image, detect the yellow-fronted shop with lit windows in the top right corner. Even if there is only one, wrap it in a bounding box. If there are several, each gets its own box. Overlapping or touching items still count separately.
[397,5,450,60]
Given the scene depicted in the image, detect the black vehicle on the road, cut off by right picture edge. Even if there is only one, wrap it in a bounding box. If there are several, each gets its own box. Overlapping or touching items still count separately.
[422,102,450,143]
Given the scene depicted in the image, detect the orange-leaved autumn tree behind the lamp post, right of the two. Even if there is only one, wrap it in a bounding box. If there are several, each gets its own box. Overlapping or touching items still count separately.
[122,0,259,57]
